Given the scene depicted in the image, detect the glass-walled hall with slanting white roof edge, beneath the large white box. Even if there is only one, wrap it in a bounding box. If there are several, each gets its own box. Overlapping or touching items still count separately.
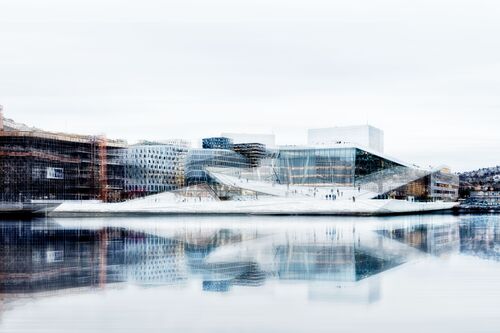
[272,143,458,201]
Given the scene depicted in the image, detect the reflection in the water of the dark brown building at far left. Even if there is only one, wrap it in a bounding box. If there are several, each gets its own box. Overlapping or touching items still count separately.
[0,222,124,294]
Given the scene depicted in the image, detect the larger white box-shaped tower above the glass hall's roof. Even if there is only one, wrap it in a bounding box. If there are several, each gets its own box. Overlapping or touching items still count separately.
[307,125,384,153]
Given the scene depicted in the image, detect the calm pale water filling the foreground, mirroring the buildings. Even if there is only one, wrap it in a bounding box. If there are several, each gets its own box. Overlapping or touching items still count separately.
[0,215,500,333]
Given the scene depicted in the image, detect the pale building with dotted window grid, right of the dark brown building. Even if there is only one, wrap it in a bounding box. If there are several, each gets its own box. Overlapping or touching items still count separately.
[121,141,188,198]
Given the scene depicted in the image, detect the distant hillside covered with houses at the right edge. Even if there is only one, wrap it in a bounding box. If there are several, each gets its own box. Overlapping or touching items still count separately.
[458,166,500,197]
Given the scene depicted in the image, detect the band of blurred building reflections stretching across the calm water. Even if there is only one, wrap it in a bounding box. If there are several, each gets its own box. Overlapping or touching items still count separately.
[0,215,486,303]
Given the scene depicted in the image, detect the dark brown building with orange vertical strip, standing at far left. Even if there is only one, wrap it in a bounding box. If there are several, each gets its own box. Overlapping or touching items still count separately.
[0,121,126,202]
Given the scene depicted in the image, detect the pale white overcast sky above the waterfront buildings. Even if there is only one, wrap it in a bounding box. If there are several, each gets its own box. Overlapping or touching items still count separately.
[0,0,500,171]
